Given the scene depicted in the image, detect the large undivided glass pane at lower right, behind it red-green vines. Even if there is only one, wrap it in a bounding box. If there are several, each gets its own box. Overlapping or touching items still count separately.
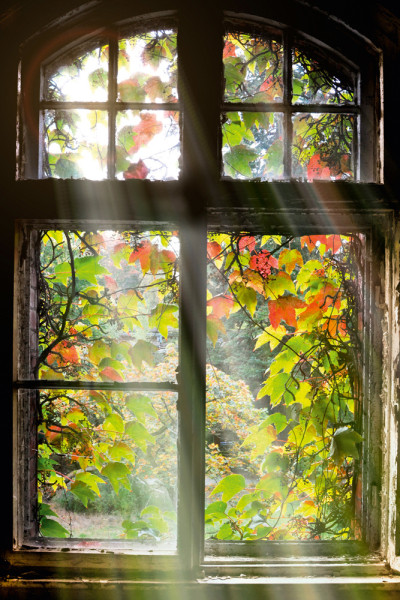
[205,233,363,541]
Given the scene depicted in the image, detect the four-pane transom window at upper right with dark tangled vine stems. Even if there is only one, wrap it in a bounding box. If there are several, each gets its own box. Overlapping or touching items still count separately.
[222,25,359,181]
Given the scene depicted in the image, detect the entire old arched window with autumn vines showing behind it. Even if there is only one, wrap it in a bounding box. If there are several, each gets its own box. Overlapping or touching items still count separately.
[15,3,386,569]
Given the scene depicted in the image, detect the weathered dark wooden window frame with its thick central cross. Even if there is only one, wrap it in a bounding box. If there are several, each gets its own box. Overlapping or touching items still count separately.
[7,1,400,577]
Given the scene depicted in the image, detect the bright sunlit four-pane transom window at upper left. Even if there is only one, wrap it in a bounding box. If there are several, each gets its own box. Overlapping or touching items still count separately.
[40,28,180,180]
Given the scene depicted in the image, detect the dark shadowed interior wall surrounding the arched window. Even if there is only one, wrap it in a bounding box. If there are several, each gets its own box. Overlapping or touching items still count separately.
[0,0,400,600]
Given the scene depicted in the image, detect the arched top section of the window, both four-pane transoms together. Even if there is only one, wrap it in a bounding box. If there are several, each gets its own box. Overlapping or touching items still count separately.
[18,9,378,181]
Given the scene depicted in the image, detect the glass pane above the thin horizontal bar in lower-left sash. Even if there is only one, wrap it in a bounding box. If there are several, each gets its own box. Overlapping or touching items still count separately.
[36,230,179,383]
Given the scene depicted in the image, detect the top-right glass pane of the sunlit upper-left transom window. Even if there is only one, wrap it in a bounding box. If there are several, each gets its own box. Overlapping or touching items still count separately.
[118,30,178,102]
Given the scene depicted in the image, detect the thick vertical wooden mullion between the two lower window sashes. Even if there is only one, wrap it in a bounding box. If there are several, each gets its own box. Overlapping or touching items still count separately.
[178,216,207,573]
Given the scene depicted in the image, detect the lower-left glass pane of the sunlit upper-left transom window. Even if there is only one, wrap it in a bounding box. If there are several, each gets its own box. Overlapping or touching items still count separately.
[42,109,108,179]
